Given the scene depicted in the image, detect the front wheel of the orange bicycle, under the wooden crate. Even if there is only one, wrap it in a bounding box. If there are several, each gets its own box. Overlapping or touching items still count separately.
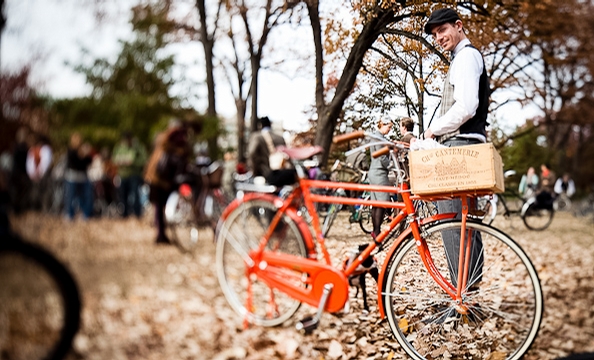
[383,221,543,360]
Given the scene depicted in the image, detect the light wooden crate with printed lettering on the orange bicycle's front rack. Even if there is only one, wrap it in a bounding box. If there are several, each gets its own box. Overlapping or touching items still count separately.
[409,143,505,195]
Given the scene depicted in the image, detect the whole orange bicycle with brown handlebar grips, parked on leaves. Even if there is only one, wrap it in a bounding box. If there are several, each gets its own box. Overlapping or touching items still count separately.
[216,132,544,359]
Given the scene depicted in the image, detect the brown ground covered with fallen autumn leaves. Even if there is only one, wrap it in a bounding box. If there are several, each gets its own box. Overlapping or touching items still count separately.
[12,213,594,360]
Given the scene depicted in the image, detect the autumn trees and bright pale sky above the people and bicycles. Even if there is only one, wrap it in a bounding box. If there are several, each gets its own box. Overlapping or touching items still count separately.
[0,0,594,193]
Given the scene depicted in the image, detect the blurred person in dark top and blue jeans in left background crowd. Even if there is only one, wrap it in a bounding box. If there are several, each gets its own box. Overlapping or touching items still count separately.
[64,132,93,220]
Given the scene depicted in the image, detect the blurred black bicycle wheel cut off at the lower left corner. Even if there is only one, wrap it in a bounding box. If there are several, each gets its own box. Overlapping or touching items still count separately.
[0,235,81,360]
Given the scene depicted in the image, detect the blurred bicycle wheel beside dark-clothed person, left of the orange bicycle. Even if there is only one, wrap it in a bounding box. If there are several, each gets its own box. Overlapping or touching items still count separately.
[165,191,202,253]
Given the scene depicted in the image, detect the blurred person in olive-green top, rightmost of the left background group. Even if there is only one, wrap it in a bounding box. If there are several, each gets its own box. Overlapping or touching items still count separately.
[113,132,147,218]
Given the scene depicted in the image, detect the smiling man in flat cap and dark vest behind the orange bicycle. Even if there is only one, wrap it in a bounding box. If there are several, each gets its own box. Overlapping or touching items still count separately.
[424,8,490,288]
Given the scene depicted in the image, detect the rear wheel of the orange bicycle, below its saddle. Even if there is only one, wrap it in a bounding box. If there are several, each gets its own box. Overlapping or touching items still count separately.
[216,199,309,326]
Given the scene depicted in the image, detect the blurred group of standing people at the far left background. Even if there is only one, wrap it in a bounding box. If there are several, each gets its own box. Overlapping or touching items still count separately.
[0,127,147,220]
